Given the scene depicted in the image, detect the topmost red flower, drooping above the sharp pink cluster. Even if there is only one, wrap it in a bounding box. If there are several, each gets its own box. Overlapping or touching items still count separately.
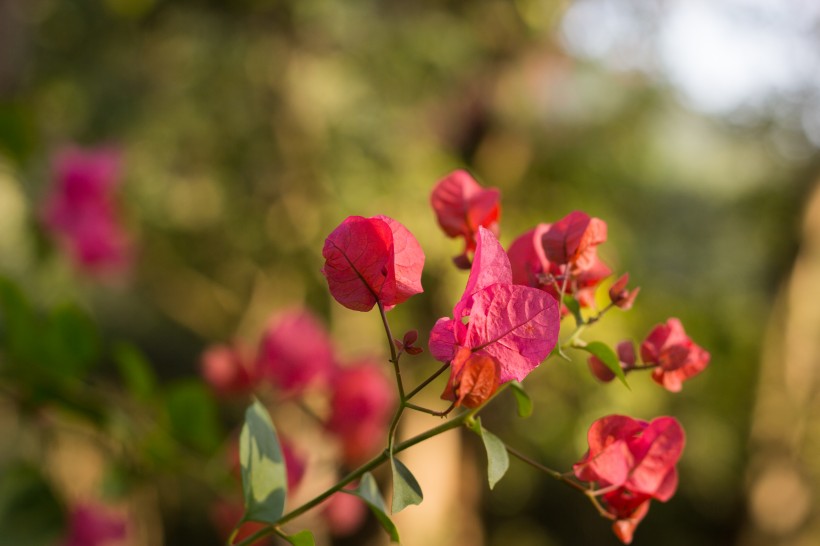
[430,170,501,269]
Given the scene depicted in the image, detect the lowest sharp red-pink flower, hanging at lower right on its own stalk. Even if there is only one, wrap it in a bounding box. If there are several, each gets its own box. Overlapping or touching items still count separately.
[573,415,686,544]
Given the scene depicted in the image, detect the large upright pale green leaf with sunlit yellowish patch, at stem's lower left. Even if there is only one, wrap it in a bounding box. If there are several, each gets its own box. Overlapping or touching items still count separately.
[239,400,288,524]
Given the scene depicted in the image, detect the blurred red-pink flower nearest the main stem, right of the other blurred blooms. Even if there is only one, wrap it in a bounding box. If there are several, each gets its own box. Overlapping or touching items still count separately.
[325,362,396,466]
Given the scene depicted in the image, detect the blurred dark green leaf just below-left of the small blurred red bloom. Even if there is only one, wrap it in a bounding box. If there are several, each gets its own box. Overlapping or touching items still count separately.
[165,381,223,453]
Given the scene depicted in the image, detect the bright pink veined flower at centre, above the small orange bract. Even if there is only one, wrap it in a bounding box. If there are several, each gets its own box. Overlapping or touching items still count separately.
[429,228,559,392]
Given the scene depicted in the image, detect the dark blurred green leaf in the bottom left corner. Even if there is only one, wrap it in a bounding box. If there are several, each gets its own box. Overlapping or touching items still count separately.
[0,463,66,546]
